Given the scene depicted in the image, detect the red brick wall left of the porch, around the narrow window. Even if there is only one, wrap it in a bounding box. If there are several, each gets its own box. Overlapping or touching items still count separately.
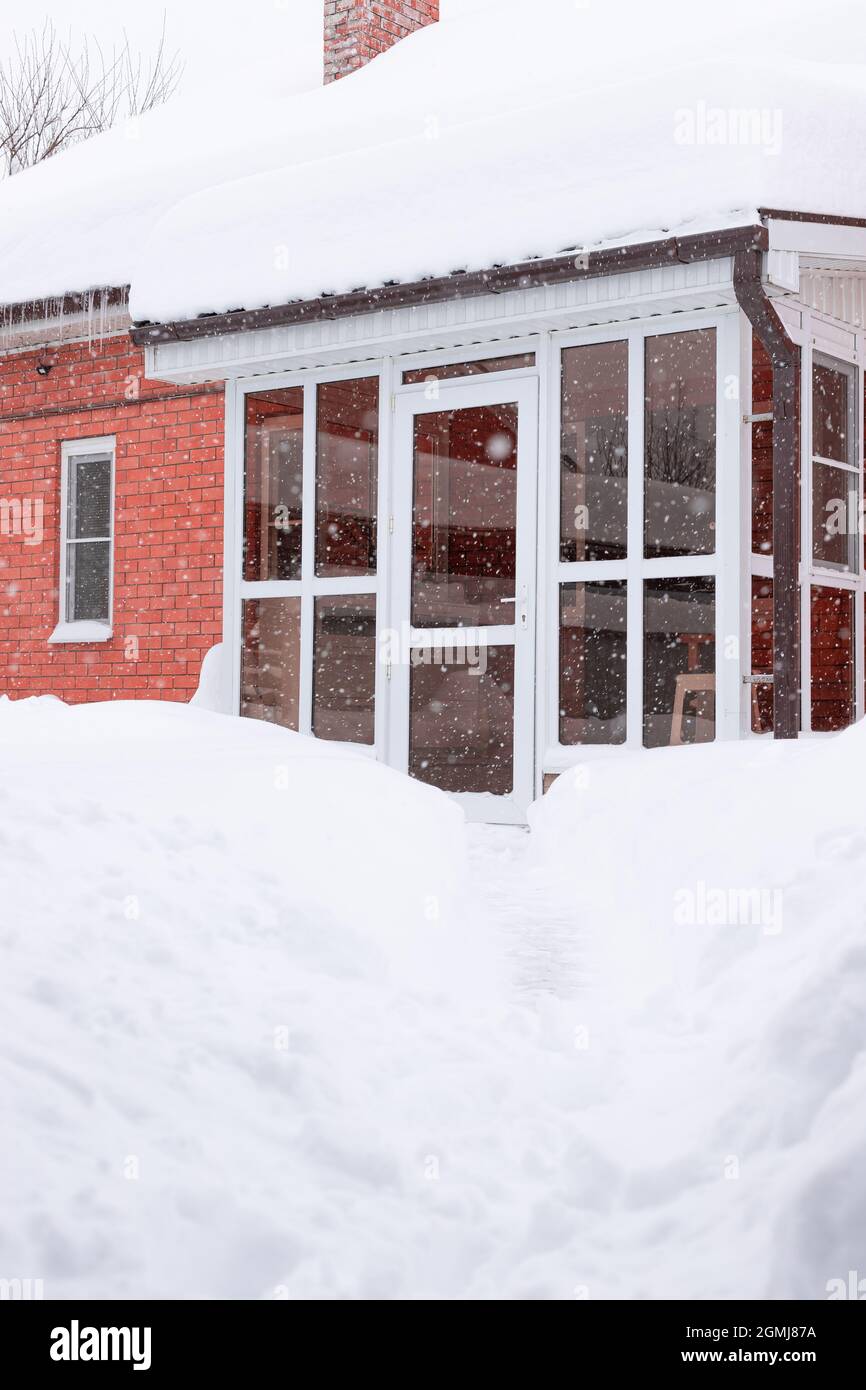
[0,335,224,702]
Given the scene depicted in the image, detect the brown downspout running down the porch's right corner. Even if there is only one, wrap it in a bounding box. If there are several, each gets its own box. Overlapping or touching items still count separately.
[734,250,801,738]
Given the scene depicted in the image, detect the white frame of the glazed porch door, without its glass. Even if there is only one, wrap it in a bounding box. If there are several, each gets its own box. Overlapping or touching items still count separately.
[382,371,538,823]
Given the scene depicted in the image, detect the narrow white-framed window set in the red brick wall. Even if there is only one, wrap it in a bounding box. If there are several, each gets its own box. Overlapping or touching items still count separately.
[50,435,115,642]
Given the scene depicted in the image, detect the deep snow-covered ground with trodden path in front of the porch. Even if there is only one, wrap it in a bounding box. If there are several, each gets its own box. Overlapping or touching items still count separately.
[0,699,866,1298]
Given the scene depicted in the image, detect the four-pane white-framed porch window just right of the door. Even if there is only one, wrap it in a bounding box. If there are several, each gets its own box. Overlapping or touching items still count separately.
[559,327,719,748]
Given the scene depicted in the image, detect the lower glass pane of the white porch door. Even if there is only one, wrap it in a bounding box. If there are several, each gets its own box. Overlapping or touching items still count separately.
[409,646,514,796]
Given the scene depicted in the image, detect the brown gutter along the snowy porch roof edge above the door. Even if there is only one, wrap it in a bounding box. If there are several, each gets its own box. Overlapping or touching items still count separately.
[132,224,769,346]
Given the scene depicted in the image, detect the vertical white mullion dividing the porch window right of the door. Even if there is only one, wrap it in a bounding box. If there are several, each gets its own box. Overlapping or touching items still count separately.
[626,328,646,748]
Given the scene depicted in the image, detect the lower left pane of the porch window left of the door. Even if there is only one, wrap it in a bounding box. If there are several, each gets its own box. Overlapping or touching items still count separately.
[240,599,300,728]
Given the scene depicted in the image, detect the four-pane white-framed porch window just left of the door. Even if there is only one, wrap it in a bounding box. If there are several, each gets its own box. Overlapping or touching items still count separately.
[240,374,379,745]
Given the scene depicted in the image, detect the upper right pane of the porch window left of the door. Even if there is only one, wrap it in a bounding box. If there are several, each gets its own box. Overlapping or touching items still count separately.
[316,377,379,577]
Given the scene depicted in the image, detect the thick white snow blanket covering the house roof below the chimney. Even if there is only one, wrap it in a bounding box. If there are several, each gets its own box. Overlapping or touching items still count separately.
[0,0,866,321]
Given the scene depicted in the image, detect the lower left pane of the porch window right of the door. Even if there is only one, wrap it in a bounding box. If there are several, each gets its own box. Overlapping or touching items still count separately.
[559,580,626,744]
